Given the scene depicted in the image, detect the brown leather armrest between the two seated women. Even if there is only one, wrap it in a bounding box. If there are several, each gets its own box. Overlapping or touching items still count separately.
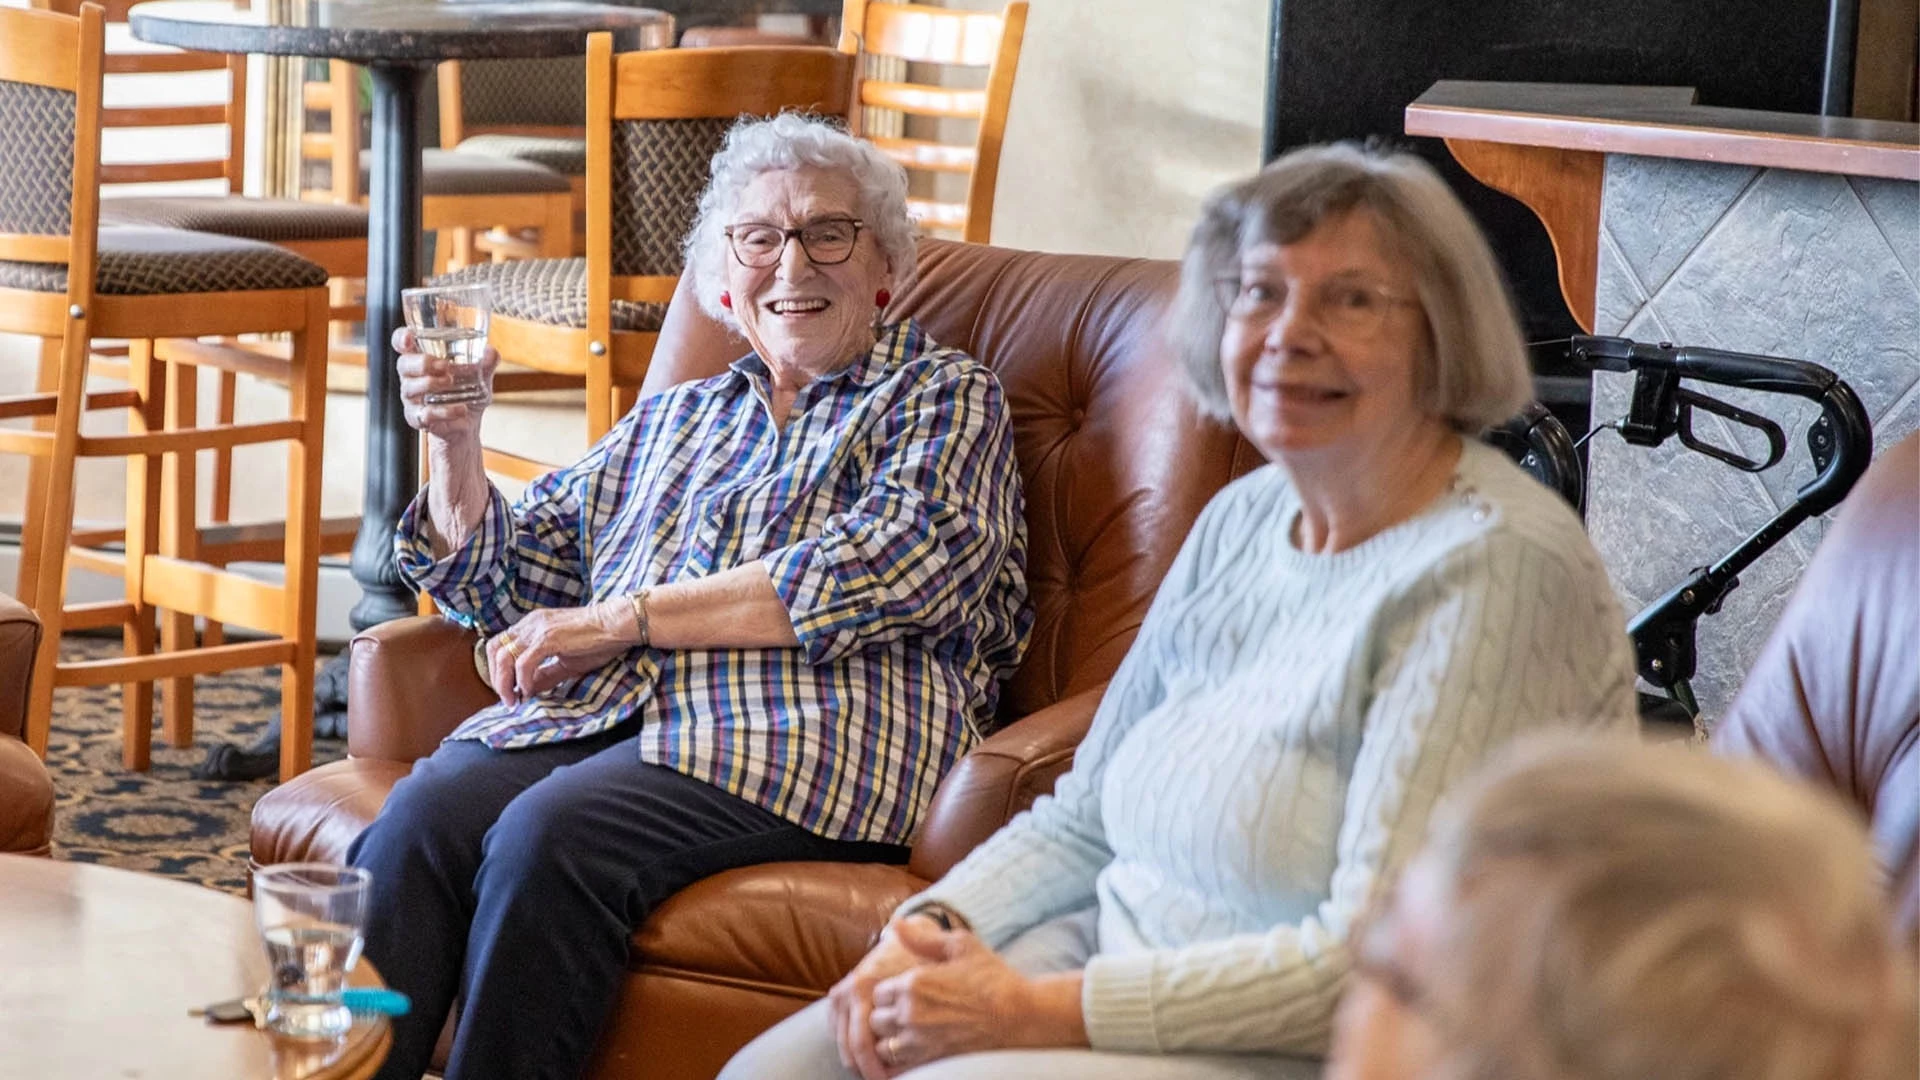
[908,682,1106,880]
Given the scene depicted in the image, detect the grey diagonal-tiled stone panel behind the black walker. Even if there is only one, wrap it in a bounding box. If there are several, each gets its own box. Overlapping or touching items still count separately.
[1588,156,1920,723]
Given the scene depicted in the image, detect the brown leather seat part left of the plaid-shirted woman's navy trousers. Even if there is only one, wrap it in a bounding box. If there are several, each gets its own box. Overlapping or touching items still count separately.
[250,757,413,867]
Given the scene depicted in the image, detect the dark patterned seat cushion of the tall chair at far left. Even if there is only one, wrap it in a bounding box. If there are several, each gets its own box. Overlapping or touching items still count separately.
[0,227,326,296]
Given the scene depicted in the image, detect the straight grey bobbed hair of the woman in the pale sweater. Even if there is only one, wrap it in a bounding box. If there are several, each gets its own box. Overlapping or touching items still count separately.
[1169,142,1532,432]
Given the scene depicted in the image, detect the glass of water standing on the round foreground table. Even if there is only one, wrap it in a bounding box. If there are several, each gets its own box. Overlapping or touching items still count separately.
[253,863,372,1040]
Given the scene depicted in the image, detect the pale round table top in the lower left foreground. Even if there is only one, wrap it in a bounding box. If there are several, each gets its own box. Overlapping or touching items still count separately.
[0,855,392,1080]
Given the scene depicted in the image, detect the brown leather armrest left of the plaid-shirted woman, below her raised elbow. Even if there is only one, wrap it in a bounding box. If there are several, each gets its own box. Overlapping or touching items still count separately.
[348,615,499,761]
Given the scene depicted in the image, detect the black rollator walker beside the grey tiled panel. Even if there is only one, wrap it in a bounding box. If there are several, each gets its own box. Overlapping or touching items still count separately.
[1486,336,1874,726]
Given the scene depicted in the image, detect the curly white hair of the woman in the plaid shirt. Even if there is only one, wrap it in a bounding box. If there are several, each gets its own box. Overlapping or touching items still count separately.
[685,111,916,327]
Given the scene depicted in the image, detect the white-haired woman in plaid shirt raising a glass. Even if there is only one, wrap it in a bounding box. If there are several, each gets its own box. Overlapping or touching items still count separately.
[349,115,1031,1080]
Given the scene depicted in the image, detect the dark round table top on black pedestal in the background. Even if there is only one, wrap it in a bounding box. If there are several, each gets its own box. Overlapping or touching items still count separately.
[127,0,674,63]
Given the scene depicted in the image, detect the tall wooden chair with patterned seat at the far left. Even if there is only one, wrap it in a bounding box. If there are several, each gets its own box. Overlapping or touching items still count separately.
[0,4,328,778]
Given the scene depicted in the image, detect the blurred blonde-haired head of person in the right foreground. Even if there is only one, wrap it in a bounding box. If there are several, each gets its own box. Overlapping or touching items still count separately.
[1327,738,1916,1080]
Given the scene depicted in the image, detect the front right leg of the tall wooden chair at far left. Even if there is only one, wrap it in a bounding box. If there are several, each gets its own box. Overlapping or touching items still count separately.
[280,292,326,782]
